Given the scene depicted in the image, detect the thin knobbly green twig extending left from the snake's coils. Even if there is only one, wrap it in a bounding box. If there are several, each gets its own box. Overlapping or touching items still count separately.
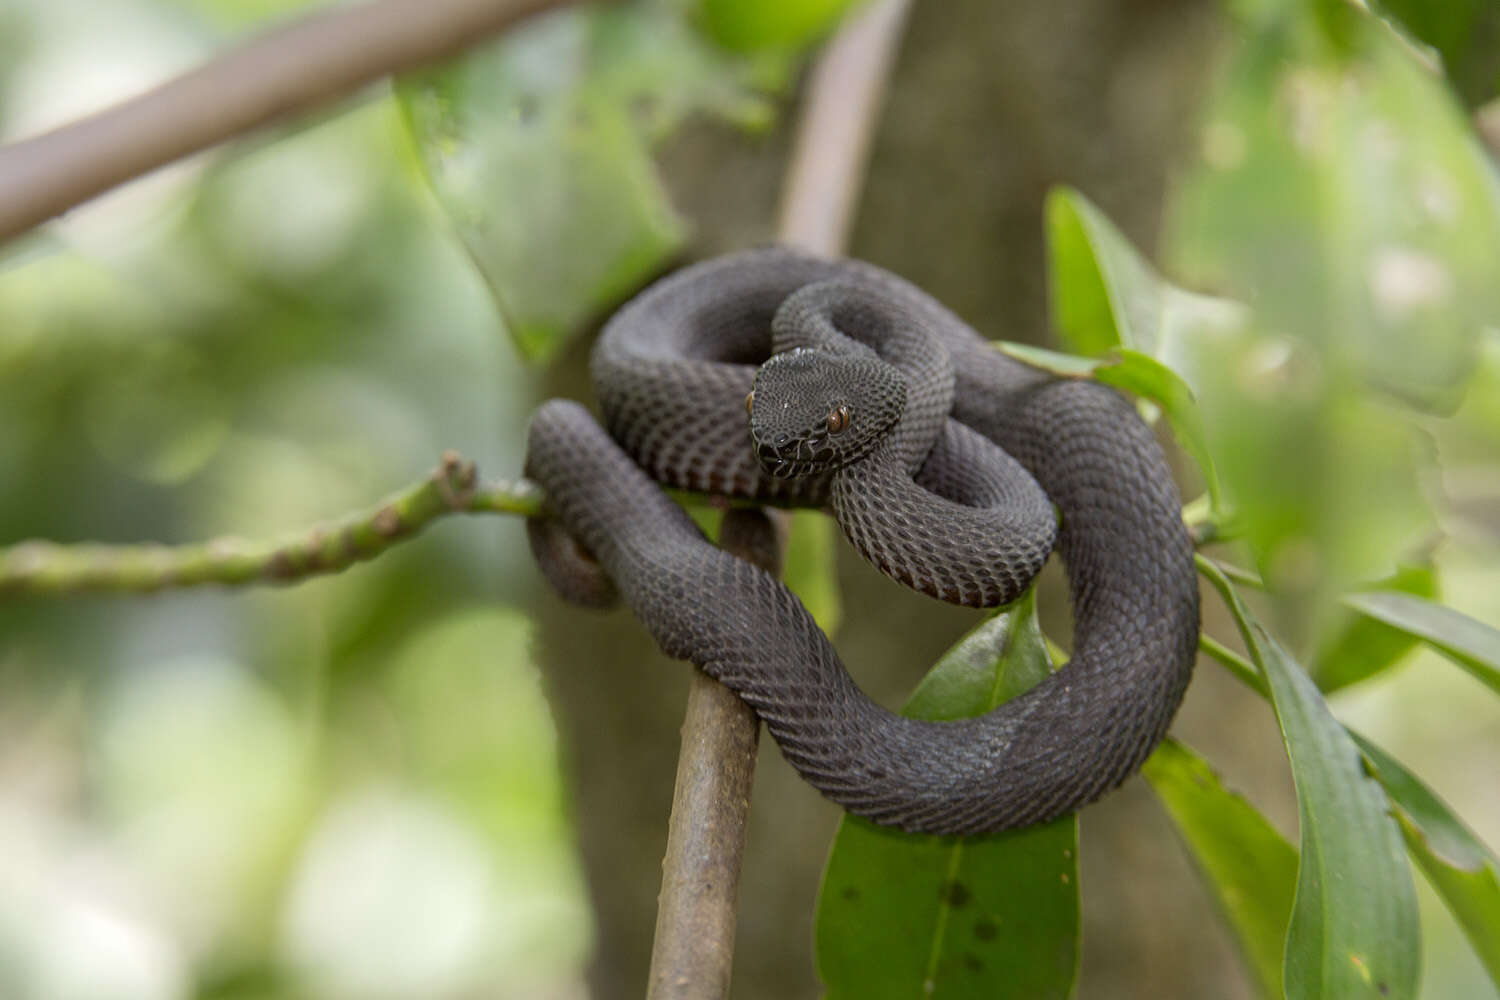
[0,451,543,595]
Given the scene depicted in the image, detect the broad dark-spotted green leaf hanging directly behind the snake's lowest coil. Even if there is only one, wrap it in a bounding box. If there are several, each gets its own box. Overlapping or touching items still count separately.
[816,591,1079,1000]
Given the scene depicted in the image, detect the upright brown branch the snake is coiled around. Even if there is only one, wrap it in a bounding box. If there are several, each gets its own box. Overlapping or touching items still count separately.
[647,0,909,1000]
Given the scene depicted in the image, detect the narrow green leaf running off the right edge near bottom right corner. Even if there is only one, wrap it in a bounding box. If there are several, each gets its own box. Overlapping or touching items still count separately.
[1350,733,1500,987]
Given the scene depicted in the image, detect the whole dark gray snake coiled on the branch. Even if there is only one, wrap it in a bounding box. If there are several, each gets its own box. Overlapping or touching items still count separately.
[527,249,1199,834]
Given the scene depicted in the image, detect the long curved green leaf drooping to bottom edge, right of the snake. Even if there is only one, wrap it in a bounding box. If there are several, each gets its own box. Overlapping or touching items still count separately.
[1199,558,1421,1000]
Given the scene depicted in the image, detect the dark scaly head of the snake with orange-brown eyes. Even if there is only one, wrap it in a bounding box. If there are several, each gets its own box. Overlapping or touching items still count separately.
[746,348,906,478]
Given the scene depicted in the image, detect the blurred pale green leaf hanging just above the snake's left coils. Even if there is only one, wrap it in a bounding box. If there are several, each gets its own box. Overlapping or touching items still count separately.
[398,1,791,360]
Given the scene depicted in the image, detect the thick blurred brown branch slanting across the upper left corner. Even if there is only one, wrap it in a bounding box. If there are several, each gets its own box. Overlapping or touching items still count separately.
[0,0,564,241]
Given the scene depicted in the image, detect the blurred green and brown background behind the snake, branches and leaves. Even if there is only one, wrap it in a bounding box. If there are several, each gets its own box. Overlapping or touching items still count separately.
[0,0,1500,1000]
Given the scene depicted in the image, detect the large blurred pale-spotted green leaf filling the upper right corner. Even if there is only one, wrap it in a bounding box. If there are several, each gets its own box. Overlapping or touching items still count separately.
[1167,4,1500,409]
